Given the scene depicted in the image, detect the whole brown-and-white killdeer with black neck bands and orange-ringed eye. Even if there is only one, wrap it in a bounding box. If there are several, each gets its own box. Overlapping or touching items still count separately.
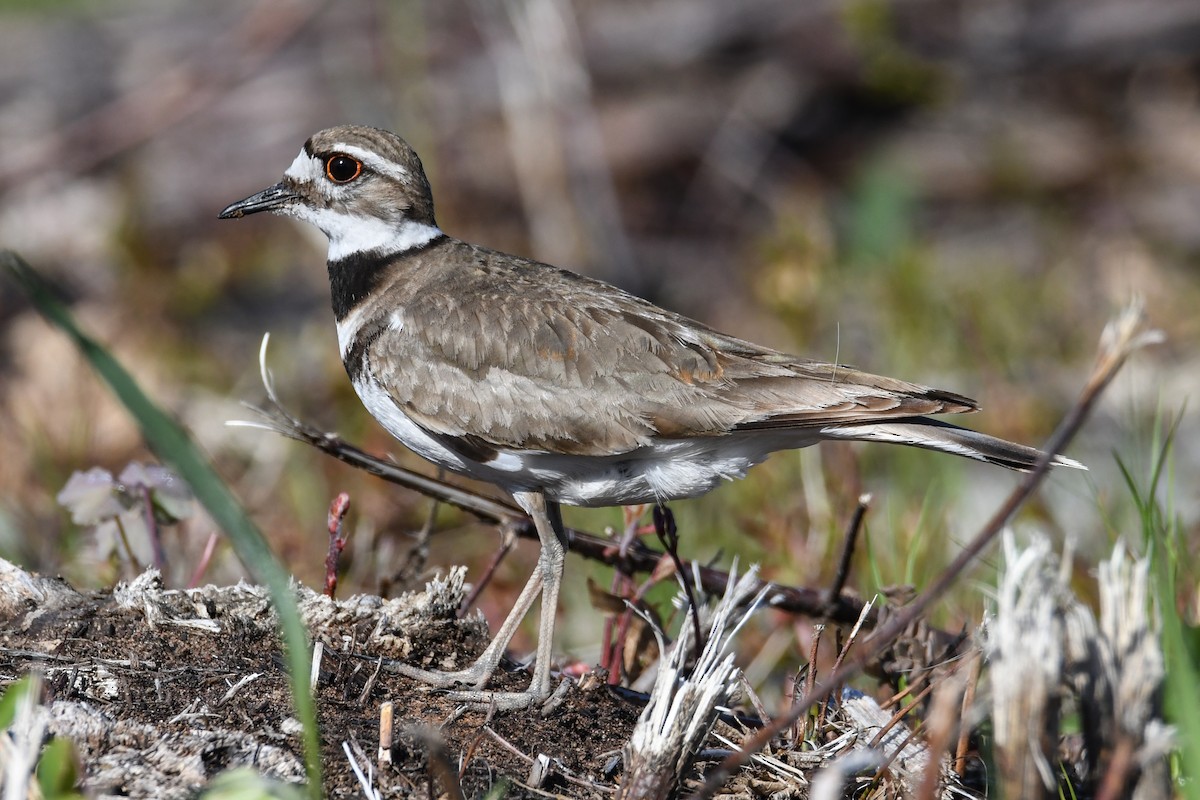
[220,126,1081,709]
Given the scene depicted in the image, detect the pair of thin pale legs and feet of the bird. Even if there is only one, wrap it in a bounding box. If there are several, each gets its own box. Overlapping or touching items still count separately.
[395,492,566,711]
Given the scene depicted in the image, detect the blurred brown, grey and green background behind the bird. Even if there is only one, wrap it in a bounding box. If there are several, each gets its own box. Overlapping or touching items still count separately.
[0,0,1200,676]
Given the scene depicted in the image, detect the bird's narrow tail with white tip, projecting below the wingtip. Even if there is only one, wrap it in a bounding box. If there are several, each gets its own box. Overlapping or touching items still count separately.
[821,416,1087,473]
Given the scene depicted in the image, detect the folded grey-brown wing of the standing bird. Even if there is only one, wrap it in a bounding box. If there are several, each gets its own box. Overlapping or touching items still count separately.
[367,245,976,456]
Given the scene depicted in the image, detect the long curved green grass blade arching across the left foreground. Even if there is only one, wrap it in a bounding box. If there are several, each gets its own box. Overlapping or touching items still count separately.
[0,251,322,798]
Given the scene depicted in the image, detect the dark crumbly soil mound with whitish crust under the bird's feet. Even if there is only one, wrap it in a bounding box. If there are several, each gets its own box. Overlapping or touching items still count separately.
[0,564,641,798]
